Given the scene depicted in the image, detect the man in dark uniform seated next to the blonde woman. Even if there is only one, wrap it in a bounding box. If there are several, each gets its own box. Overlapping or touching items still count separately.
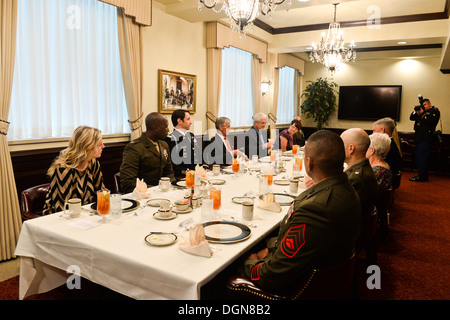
[120,112,175,193]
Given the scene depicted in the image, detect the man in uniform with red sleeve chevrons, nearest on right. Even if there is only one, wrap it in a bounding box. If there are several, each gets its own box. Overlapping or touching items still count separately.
[241,130,361,293]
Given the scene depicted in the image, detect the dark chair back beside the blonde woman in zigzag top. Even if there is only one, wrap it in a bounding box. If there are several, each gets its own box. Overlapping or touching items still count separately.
[20,183,50,221]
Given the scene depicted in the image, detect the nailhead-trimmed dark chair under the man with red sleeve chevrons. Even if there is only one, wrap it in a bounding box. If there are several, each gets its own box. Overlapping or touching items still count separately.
[227,254,356,300]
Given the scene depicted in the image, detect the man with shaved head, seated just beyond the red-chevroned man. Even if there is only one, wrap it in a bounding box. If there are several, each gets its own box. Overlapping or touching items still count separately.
[341,128,378,215]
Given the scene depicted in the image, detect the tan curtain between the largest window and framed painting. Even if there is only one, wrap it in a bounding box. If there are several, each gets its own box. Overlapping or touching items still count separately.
[117,8,143,140]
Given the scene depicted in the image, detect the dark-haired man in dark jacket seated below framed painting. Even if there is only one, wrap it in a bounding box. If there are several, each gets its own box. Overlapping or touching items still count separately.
[166,109,202,177]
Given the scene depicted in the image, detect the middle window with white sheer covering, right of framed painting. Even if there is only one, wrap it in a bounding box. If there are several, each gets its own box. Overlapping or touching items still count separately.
[218,47,254,127]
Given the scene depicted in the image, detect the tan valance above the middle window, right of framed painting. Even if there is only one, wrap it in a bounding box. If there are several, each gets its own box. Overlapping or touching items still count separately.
[206,21,268,63]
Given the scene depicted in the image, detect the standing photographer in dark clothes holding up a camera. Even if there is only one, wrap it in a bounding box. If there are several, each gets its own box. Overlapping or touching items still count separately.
[409,95,441,182]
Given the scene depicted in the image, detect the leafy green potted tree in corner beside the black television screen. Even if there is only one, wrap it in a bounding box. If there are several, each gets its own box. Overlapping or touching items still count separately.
[301,78,338,130]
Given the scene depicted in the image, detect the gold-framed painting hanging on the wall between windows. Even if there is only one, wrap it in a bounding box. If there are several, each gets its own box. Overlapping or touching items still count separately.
[158,69,197,113]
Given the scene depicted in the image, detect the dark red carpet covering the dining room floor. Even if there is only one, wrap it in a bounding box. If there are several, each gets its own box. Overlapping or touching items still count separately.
[0,171,450,300]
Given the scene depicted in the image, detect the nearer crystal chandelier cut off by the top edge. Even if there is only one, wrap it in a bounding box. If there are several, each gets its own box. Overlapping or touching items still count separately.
[198,0,291,34]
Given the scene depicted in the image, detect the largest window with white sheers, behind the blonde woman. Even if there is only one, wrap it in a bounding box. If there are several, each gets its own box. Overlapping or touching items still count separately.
[8,0,130,140]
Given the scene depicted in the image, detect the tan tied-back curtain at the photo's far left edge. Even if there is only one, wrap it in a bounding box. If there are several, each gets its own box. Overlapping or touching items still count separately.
[0,0,22,260]
